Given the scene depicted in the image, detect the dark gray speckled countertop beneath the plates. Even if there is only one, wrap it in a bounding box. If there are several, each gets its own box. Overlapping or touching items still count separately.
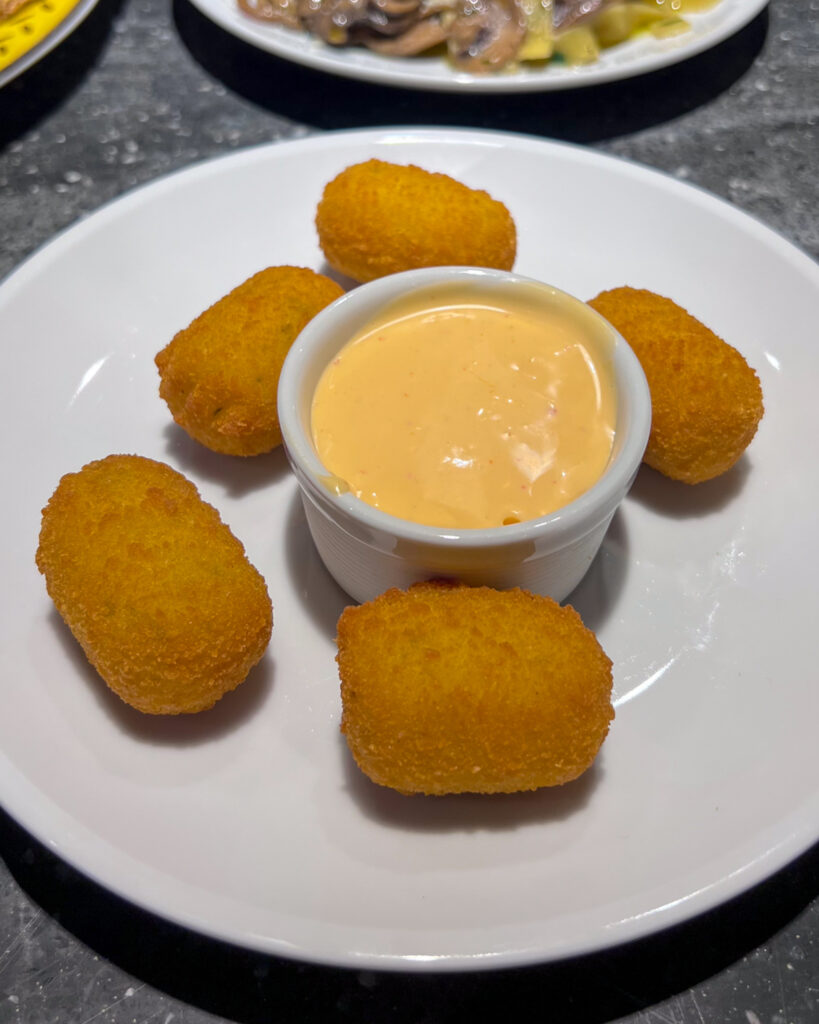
[0,0,819,1024]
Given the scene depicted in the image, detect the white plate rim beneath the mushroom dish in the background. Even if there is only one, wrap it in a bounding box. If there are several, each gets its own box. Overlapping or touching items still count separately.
[184,0,768,92]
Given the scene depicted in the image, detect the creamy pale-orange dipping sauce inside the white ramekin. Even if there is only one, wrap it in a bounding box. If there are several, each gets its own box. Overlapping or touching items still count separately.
[312,288,616,528]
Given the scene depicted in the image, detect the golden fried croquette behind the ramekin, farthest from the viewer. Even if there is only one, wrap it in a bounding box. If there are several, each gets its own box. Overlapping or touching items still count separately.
[315,160,517,282]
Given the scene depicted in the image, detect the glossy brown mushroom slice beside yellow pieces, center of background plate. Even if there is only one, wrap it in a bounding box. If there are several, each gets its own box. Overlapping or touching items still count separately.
[447,0,526,73]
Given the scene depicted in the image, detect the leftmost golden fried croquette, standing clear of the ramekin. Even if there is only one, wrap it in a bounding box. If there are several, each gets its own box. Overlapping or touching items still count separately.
[37,455,272,715]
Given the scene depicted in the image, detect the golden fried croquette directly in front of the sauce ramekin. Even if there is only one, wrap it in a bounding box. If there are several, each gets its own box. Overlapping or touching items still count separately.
[337,583,614,795]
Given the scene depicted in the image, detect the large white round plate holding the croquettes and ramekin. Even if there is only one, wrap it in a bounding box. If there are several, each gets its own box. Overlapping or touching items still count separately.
[0,128,819,970]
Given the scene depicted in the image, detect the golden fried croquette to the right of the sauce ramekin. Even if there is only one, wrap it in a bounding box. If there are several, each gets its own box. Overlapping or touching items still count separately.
[589,288,765,483]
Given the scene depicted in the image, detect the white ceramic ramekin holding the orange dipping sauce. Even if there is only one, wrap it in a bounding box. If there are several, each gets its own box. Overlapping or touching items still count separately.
[278,267,651,601]
